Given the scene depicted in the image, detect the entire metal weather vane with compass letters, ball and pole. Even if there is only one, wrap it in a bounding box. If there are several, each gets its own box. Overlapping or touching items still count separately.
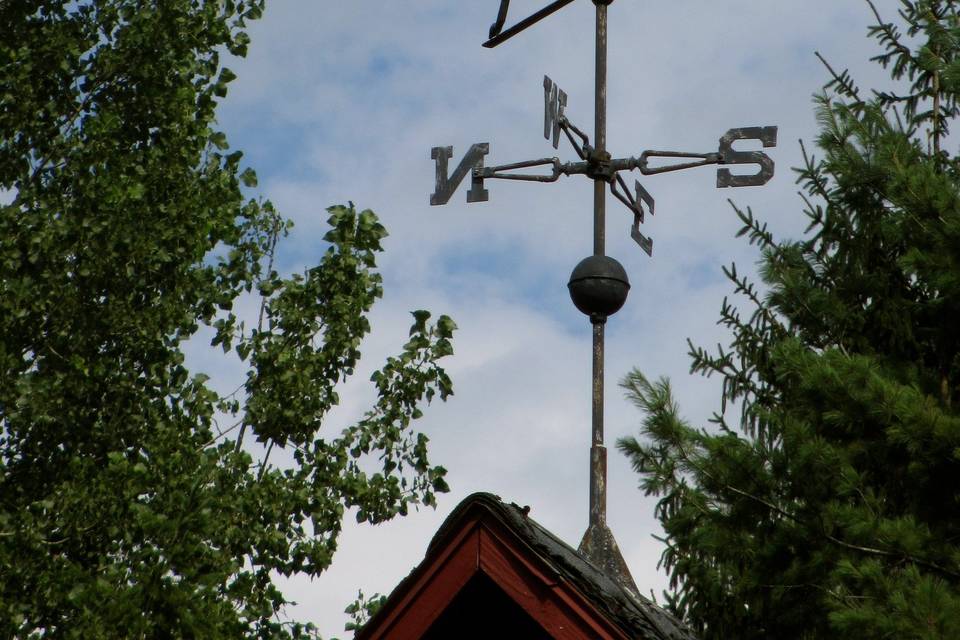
[430,0,777,590]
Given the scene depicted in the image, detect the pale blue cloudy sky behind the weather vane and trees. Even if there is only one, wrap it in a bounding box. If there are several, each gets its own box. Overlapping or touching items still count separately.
[194,0,898,636]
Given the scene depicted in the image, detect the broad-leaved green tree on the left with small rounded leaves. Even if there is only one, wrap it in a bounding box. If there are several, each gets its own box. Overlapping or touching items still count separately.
[0,0,455,638]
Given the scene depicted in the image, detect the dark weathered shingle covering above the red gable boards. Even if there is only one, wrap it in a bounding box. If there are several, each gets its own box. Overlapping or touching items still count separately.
[356,493,696,640]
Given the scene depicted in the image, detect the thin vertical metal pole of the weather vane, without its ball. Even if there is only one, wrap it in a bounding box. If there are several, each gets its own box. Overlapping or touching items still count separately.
[590,0,611,526]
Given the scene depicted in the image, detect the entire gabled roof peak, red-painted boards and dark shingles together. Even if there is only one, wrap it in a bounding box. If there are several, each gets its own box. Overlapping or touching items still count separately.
[356,493,695,640]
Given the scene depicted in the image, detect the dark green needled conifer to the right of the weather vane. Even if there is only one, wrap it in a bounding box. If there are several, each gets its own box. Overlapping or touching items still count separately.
[619,0,960,639]
